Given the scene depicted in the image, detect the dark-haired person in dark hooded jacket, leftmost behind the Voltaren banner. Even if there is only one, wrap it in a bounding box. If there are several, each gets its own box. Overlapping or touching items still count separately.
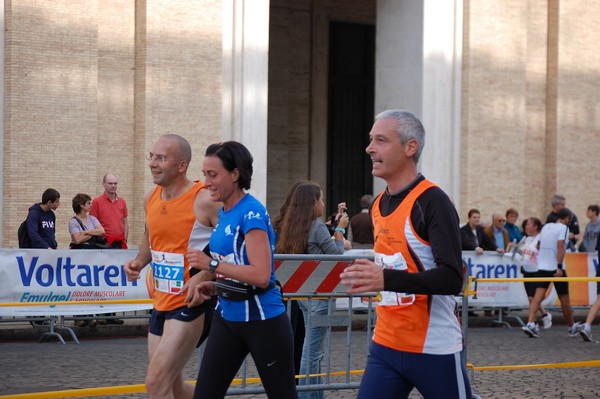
[27,188,60,249]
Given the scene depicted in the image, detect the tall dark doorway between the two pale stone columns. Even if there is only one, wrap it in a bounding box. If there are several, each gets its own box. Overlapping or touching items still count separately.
[326,22,375,220]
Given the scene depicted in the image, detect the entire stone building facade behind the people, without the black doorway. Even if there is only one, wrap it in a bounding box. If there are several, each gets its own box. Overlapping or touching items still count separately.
[0,0,600,248]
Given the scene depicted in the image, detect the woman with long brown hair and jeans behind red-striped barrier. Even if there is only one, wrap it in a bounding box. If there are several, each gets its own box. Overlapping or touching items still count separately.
[275,181,349,399]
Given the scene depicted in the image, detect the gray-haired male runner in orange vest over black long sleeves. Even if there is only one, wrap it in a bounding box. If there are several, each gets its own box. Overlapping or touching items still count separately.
[340,110,472,399]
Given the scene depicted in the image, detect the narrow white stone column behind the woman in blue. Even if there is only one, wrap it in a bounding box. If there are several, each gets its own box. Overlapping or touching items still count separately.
[222,0,269,203]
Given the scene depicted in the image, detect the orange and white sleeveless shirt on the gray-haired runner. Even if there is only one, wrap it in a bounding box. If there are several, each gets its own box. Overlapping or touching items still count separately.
[371,180,462,354]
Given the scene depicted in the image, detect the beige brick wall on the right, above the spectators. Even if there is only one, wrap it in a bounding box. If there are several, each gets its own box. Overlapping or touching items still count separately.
[460,0,600,228]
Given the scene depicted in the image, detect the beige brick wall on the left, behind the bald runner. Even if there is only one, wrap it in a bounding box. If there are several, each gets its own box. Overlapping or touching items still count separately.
[3,0,222,248]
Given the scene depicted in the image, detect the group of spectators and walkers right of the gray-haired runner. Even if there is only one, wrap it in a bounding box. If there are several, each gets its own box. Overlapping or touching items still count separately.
[460,194,600,342]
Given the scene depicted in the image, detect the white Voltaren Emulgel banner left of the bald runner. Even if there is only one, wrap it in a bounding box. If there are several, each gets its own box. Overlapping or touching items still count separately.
[0,249,152,316]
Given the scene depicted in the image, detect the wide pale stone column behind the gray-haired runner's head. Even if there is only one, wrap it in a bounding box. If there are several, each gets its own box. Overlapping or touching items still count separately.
[374,0,463,207]
